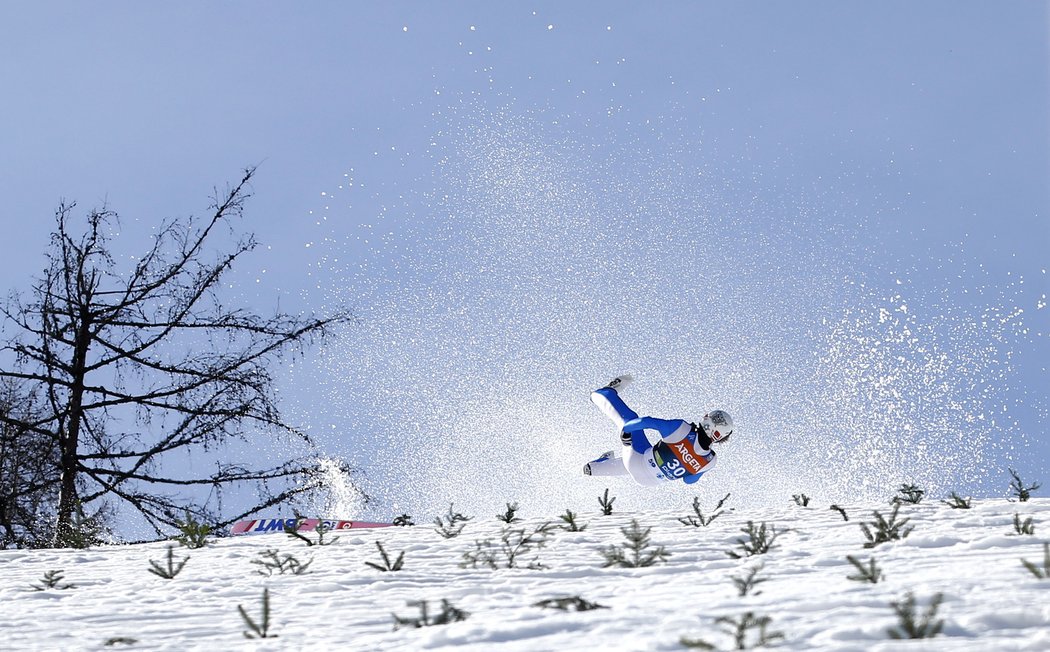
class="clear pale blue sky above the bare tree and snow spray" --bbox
[0,2,1050,516]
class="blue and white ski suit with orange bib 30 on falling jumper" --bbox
[590,387,715,486]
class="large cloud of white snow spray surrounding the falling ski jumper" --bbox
[296,96,1045,520]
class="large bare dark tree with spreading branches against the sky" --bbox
[0,168,359,545]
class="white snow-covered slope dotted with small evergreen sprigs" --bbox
[0,497,1050,651]
